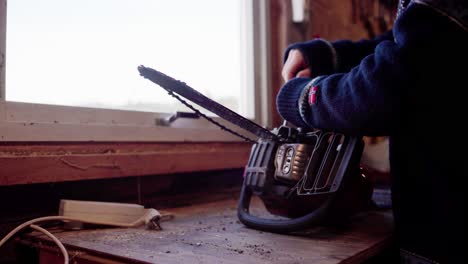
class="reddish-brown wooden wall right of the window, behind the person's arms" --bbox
[270,0,398,126]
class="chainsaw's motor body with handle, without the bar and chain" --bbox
[238,128,373,231]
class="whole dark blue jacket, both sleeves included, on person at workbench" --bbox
[277,1,468,263]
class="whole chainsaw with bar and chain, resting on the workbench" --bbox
[138,66,373,233]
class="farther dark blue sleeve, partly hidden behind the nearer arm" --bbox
[284,31,393,77]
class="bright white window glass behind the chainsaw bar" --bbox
[6,0,245,114]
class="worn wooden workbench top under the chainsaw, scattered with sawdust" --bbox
[19,199,393,264]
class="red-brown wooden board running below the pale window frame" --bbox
[0,143,251,186]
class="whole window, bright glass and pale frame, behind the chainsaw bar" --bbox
[0,0,270,141]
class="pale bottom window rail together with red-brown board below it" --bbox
[0,102,254,186]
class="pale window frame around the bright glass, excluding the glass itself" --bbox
[0,0,272,142]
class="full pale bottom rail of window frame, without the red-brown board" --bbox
[0,101,260,142]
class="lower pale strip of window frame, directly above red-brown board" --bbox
[0,121,250,143]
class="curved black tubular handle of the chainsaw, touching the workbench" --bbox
[237,185,334,233]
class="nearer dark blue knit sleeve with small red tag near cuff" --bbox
[277,38,407,136]
